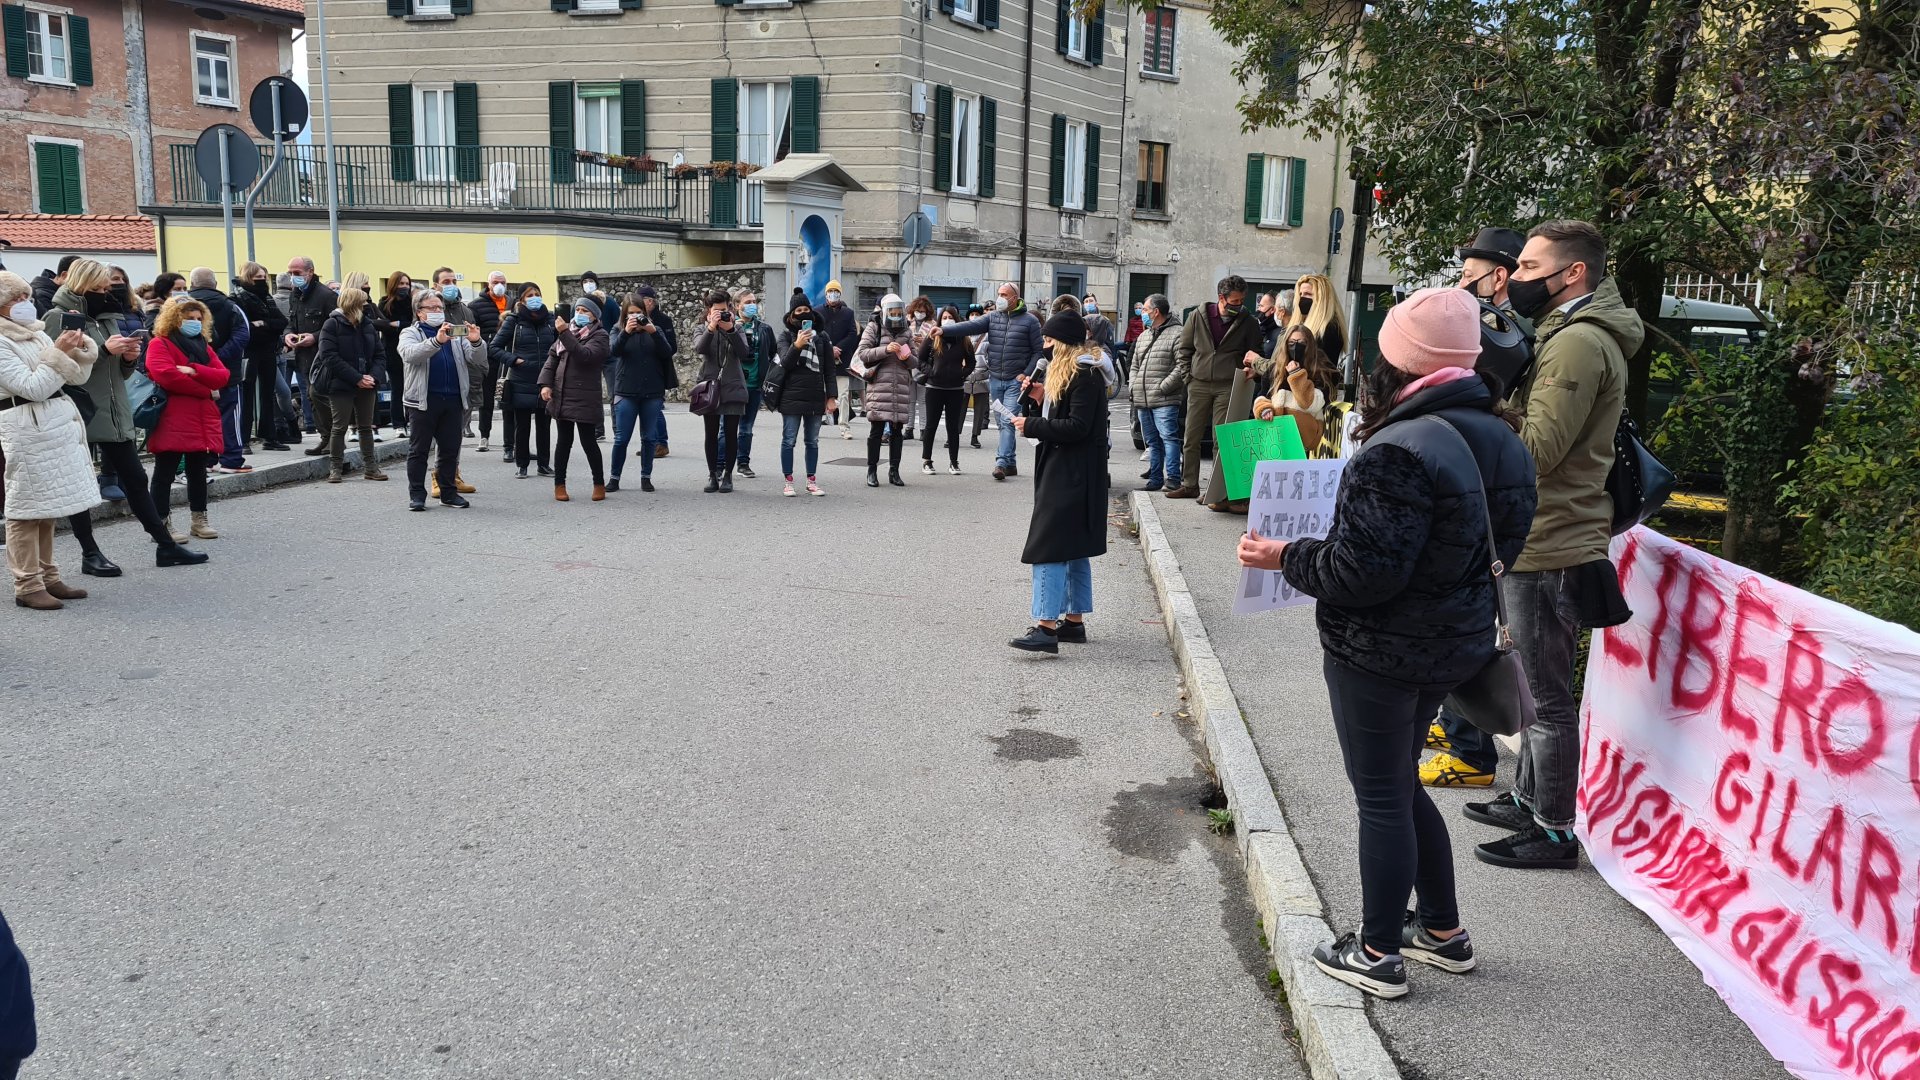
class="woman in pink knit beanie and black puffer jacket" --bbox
[1238,288,1534,997]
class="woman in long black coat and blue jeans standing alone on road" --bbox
[1008,311,1108,653]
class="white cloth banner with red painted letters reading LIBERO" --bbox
[1578,528,1920,1080]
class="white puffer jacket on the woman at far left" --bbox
[0,317,100,521]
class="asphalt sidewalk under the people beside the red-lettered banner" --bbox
[1128,494,1788,1080]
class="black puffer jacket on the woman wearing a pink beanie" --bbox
[1283,379,1534,690]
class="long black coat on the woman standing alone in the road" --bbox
[1020,365,1108,563]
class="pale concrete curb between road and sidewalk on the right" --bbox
[1133,492,1400,1080]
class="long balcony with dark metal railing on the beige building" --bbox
[167,142,758,229]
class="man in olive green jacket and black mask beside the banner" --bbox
[1467,221,1645,871]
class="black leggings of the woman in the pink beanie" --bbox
[1323,657,1459,953]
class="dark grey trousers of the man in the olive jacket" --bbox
[1501,571,1580,830]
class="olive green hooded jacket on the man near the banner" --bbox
[1513,277,1647,573]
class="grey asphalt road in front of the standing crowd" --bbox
[0,411,1302,1080]
